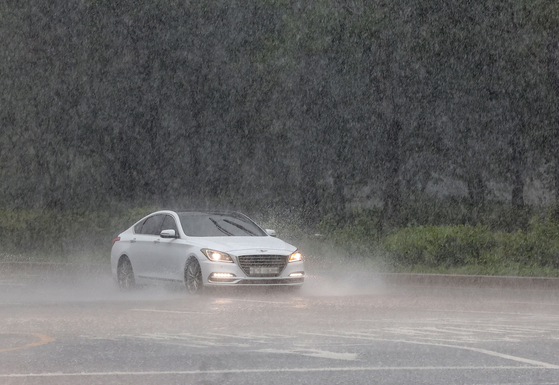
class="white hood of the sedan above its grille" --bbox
[190,237,297,255]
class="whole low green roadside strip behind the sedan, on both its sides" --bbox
[0,207,559,277]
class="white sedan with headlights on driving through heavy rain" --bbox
[111,211,305,293]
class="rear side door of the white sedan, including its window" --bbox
[132,214,165,279]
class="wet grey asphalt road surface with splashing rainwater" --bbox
[0,264,559,385]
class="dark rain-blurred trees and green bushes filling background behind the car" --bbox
[0,0,559,275]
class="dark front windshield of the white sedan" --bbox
[178,212,266,237]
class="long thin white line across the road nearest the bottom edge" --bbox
[0,366,556,378]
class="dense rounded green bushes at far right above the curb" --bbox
[381,218,559,275]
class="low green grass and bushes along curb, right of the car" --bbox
[312,208,559,277]
